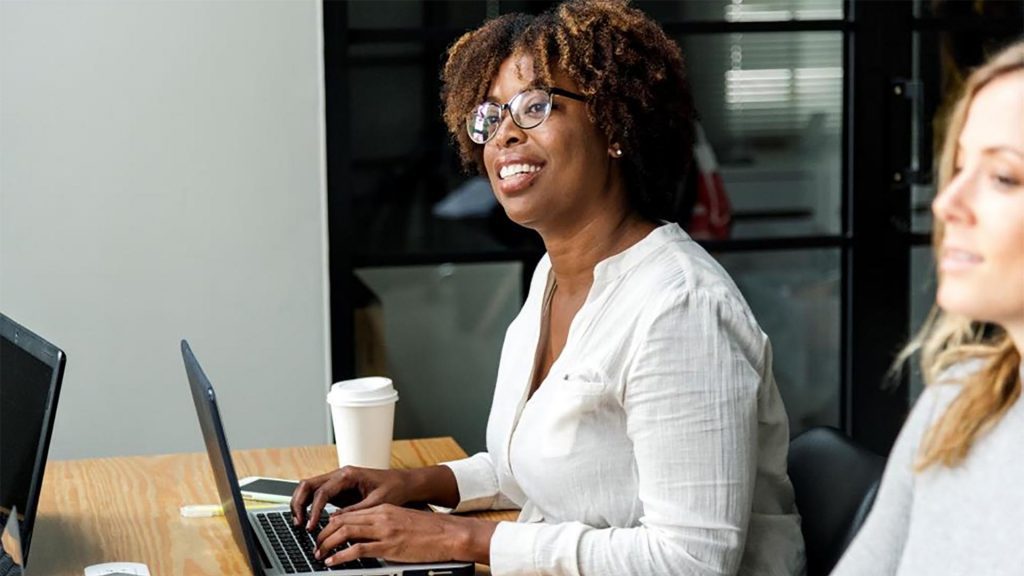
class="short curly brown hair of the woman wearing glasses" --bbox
[441,0,695,220]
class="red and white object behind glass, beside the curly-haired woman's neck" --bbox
[687,124,732,240]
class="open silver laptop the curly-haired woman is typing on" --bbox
[181,340,475,576]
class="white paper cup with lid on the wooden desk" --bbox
[327,376,398,469]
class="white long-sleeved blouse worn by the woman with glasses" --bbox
[446,224,804,576]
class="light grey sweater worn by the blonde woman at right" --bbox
[833,364,1024,576]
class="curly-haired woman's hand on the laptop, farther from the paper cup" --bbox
[316,504,498,566]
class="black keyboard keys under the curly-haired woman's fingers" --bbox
[256,511,381,574]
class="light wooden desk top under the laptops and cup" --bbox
[28,438,516,576]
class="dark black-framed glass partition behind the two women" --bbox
[325,0,1024,452]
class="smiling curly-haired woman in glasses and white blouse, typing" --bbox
[292,0,803,576]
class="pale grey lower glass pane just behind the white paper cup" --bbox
[356,262,523,453]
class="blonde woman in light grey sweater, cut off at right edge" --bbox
[834,42,1024,576]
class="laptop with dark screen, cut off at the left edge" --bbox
[0,314,66,566]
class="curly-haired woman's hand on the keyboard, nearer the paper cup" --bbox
[291,466,415,530]
